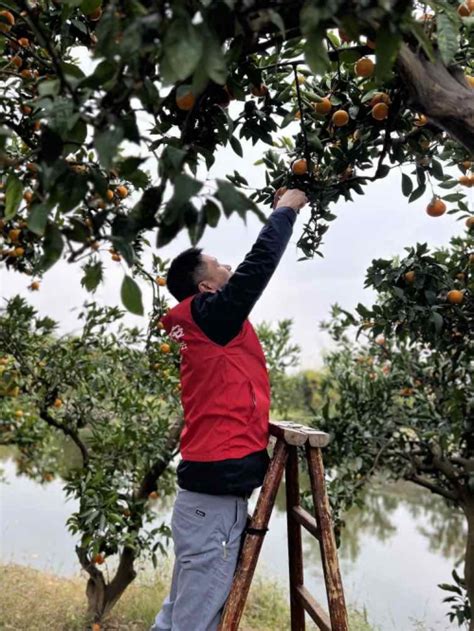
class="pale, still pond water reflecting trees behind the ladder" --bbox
[0,456,465,631]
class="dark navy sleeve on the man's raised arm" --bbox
[191,207,296,344]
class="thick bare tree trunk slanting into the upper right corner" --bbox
[398,44,474,153]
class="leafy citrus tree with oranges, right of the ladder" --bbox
[306,237,474,628]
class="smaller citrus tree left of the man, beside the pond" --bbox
[0,256,182,623]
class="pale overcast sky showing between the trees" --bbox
[0,49,466,368]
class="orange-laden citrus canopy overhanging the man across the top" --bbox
[0,0,474,313]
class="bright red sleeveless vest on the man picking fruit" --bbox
[162,296,270,462]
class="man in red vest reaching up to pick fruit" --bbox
[150,189,307,631]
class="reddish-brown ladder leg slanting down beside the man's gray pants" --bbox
[219,440,288,631]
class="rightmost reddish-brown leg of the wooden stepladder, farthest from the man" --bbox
[306,443,349,631]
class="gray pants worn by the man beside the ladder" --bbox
[150,487,248,631]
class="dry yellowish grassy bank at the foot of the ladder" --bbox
[0,564,374,631]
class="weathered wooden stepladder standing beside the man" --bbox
[219,421,349,631]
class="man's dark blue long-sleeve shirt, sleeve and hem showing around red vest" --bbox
[177,207,296,495]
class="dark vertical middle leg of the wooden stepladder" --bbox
[285,446,305,631]
